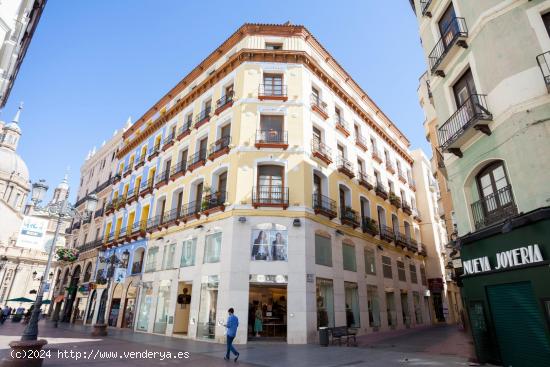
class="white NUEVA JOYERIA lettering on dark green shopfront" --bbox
[462,244,544,275]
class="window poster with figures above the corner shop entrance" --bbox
[251,229,288,261]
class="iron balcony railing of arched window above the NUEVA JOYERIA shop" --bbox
[471,185,518,230]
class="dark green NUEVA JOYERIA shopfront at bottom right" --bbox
[461,208,550,367]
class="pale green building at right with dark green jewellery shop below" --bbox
[411,0,550,366]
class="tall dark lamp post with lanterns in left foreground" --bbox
[6,180,98,366]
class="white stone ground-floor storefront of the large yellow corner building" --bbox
[125,217,433,344]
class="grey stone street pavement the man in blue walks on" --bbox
[0,321,478,367]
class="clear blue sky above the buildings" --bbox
[0,0,429,200]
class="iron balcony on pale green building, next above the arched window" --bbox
[437,94,493,157]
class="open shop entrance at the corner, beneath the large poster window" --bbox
[248,283,287,341]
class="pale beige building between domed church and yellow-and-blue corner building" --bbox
[52,125,124,324]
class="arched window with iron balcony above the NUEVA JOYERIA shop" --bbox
[472,161,517,229]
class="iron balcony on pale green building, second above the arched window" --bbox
[428,18,468,77]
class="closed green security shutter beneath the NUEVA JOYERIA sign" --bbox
[487,282,550,367]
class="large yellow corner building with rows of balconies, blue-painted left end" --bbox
[89,24,440,343]
